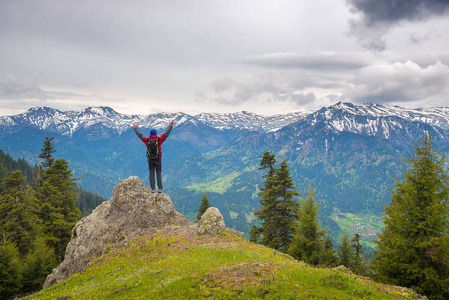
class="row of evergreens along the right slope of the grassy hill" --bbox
[250,128,449,299]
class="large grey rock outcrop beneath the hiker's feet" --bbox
[44,177,243,288]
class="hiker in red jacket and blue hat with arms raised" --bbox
[133,120,174,193]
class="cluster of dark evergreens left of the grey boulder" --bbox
[0,137,104,299]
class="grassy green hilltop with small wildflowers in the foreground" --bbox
[24,235,417,299]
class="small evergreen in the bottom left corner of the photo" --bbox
[0,241,22,299]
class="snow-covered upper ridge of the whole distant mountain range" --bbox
[0,102,449,139]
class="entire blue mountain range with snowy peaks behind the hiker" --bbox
[0,102,449,243]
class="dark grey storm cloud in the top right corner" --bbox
[346,0,449,51]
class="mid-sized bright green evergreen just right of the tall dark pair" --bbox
[289,186,326,265]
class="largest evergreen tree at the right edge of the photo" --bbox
[373,128,449,299]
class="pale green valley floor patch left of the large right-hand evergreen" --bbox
[331,210,385,249]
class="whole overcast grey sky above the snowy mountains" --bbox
[0,0,449,115]
